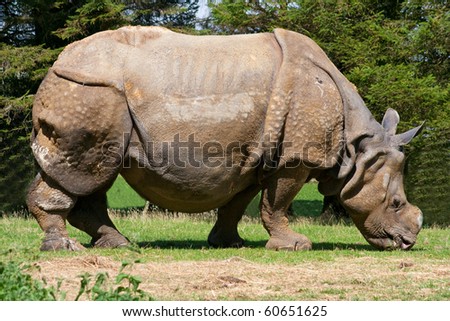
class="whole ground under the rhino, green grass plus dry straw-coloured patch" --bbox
[0,212,450,300]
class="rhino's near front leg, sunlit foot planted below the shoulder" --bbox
[260,167,312,251]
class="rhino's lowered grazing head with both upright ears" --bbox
[339,109,423,250]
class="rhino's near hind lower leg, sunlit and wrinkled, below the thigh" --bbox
[27,174,84,251]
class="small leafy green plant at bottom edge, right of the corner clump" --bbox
[75,262,152,301]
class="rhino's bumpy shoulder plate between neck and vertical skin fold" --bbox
[264,29,344,168]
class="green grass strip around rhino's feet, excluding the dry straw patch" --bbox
[0,212,450,264]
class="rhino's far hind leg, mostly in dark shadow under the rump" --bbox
[67,191,129,248]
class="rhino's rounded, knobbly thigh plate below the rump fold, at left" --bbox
[31,71,132,196]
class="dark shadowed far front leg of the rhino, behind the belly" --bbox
[208,186,261,248]
